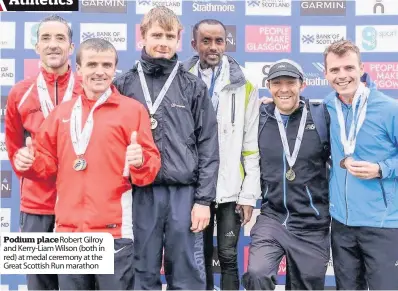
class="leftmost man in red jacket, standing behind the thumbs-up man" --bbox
[5,16,81,290]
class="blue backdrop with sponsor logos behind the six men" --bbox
[0,0,398,290]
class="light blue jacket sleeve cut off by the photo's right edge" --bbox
[378,104,398,179]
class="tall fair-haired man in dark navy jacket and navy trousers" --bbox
[115,7,219,290]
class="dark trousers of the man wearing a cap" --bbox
[242,215,330,290]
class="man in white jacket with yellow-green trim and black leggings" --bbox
[184,19,261,290]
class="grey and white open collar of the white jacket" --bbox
[183,55,246,90]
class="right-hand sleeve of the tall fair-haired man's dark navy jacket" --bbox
[192,79,220,205]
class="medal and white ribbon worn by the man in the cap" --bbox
[275,100,308,181]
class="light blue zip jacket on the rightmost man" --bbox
[324,75,398,228]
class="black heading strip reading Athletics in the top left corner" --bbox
[0,0,79,11]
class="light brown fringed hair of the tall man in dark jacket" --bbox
[140,6,183,38]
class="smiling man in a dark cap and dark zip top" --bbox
[242,60,330,290]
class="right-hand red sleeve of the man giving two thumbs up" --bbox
[130,104,161,187]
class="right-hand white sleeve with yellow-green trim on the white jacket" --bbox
[237,81,261,207]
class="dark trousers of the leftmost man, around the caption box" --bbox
[19,211,59,290]
